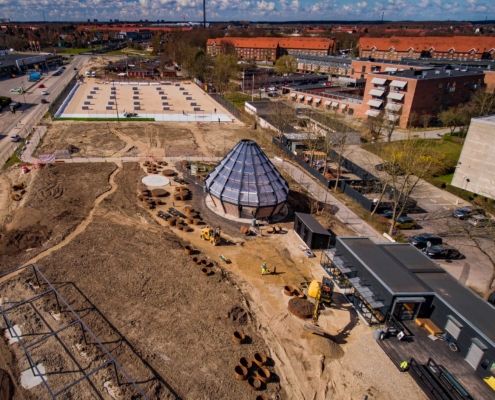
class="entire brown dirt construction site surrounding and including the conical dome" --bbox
[0,77,425,400]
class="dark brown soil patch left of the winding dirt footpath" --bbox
[0,163,116,271]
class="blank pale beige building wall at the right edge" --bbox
[452,115,495,199]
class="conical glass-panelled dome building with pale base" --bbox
[205,139,289,218]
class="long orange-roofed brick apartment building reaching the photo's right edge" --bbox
[359,36,495,61]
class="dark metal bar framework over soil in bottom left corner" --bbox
[0,265,180,399]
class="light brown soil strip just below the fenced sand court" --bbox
[35,121,257,157]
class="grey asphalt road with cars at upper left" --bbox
[0,56,90,164]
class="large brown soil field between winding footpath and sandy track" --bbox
[7,164,280,400]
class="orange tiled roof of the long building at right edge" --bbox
[359,36,495,53]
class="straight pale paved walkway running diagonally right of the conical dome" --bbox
[272,157,386,242]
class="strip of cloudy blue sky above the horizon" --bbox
[0,0,495,21]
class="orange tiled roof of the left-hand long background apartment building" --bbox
[206,36,333,50]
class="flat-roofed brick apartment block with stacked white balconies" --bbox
[360,68,484,128]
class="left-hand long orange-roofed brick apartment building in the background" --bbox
[206,36,335,62]
